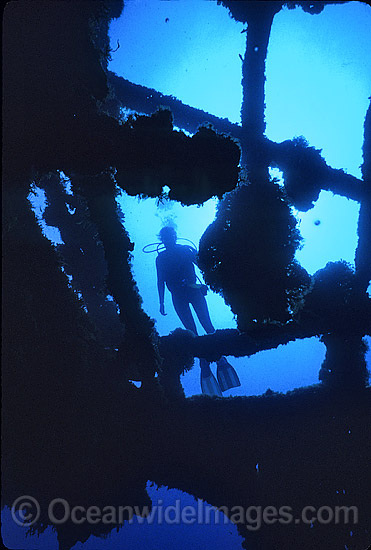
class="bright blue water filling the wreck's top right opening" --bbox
[265,2,371,177]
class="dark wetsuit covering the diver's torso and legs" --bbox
[156,244,215,334]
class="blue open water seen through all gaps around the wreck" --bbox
[2,0,371,550]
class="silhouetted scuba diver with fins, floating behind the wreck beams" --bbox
[156,226,241,397]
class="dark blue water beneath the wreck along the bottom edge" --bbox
[2,482,247,550]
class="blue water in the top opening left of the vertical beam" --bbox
[109,0,246,122]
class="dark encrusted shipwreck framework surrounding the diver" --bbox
[3,0,371,550]
